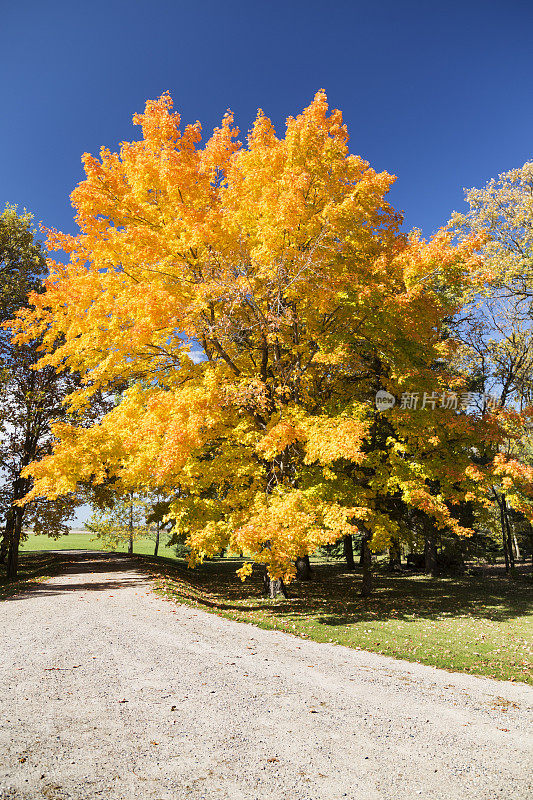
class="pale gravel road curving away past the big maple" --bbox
[0,553,533,800]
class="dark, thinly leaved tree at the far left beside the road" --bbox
[0,206,84,578]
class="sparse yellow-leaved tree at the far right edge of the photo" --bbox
[451,162,533,569]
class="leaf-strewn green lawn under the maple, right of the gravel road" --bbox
[137,557,533,683]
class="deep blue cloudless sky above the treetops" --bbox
[0,0,533,524]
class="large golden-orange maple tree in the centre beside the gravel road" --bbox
[11,92,520,593]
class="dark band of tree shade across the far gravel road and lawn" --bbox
[4,550,533,628]
